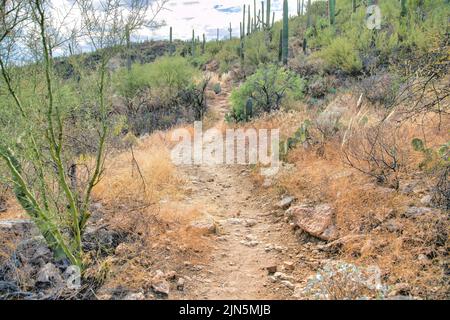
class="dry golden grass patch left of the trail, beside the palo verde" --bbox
[90,128,213,292]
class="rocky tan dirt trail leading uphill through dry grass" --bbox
[172,81,306,299]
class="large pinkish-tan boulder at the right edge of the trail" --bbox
[287,204,338,241]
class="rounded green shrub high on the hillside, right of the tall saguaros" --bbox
[319,37,362,75]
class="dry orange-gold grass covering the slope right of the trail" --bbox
[251,98,450,299]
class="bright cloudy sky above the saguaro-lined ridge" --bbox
[51,0,306,41]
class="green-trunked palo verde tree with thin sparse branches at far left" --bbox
[0,0,167,268]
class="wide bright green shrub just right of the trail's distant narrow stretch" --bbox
[230,65,304,121]
